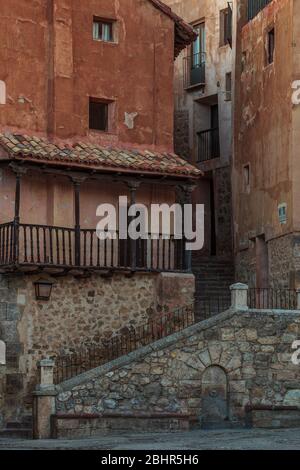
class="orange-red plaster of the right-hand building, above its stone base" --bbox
[233,0,293,248]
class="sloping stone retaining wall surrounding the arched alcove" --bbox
[56,311,300,425]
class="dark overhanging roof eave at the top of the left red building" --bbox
[149,0,197,58]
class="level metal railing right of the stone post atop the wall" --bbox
[248,288,298,310]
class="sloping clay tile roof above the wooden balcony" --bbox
[0,133,202,182]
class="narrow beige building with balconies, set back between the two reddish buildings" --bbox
[167,0,235,302]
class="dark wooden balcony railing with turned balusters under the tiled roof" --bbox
[0,222,188,271]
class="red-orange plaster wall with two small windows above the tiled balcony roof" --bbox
[0,0,174,150]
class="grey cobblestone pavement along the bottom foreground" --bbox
[0,429,300,450]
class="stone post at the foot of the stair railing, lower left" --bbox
[33,359,57,439]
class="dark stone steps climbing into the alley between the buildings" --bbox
[193,257,235,319]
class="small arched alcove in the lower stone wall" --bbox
[201,366,229,428]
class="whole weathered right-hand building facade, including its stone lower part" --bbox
[232,0,300,288]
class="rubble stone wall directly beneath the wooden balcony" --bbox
[0,274,195,426]
